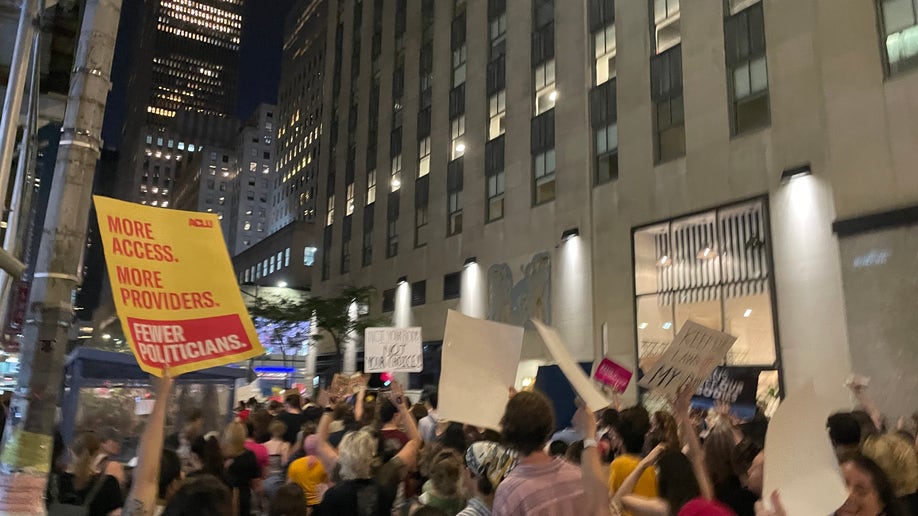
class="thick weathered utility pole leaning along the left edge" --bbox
[0,0,121,514]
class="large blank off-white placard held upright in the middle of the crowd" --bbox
[438,310,523,430]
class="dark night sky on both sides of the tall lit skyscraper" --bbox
[102,0,295,148]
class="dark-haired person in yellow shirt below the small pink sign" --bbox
[609,405,657,512]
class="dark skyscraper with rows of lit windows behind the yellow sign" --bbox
[119,0,243,207]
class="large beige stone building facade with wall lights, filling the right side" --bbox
[314,0,918,415]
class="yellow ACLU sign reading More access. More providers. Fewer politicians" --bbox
[93,196,264,376]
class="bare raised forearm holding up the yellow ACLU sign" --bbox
[122,370,173,516]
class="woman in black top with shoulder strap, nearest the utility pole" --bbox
[49,432,124,516]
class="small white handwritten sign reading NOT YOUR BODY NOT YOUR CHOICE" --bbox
[363,328,424,373]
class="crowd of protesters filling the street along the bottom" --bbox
[41,368,918,516]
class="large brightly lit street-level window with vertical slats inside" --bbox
[633,201,776,367]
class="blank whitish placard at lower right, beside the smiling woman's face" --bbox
[763,382,848,514]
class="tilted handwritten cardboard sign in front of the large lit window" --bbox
[638,321,736,398]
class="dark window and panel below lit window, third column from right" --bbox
[650,45,685,163]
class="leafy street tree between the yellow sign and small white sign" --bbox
[249,286,385,370]
